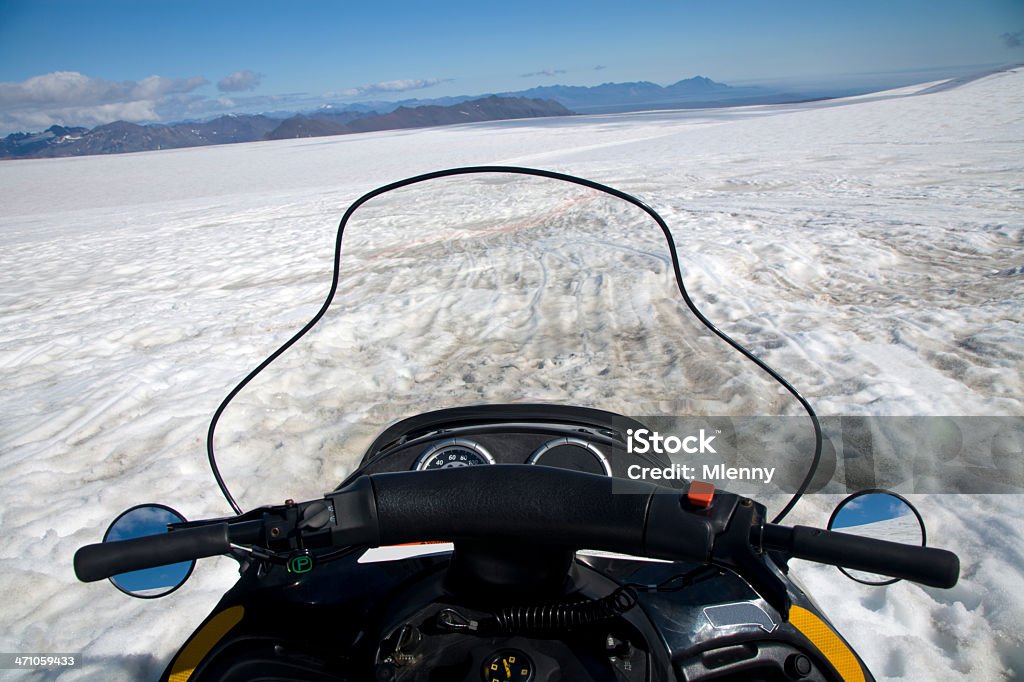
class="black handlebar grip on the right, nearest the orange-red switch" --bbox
[762,524,959,588]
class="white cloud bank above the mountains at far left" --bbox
[0,71,209,130]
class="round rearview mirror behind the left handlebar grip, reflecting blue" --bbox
[103,505,196,599]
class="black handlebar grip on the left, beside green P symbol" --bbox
[75,523,230,583]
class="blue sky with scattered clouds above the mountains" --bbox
[0,0,1024,132]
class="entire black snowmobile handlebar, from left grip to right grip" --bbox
[75,465,959,602]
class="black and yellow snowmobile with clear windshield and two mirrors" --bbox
[75,167,959,682]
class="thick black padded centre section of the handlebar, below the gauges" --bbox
[328,464,720,561]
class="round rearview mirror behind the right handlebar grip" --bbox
[828,489,927,585]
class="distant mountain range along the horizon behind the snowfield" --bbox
[0,76,801,159]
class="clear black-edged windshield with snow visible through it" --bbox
[215,173,807,509]
